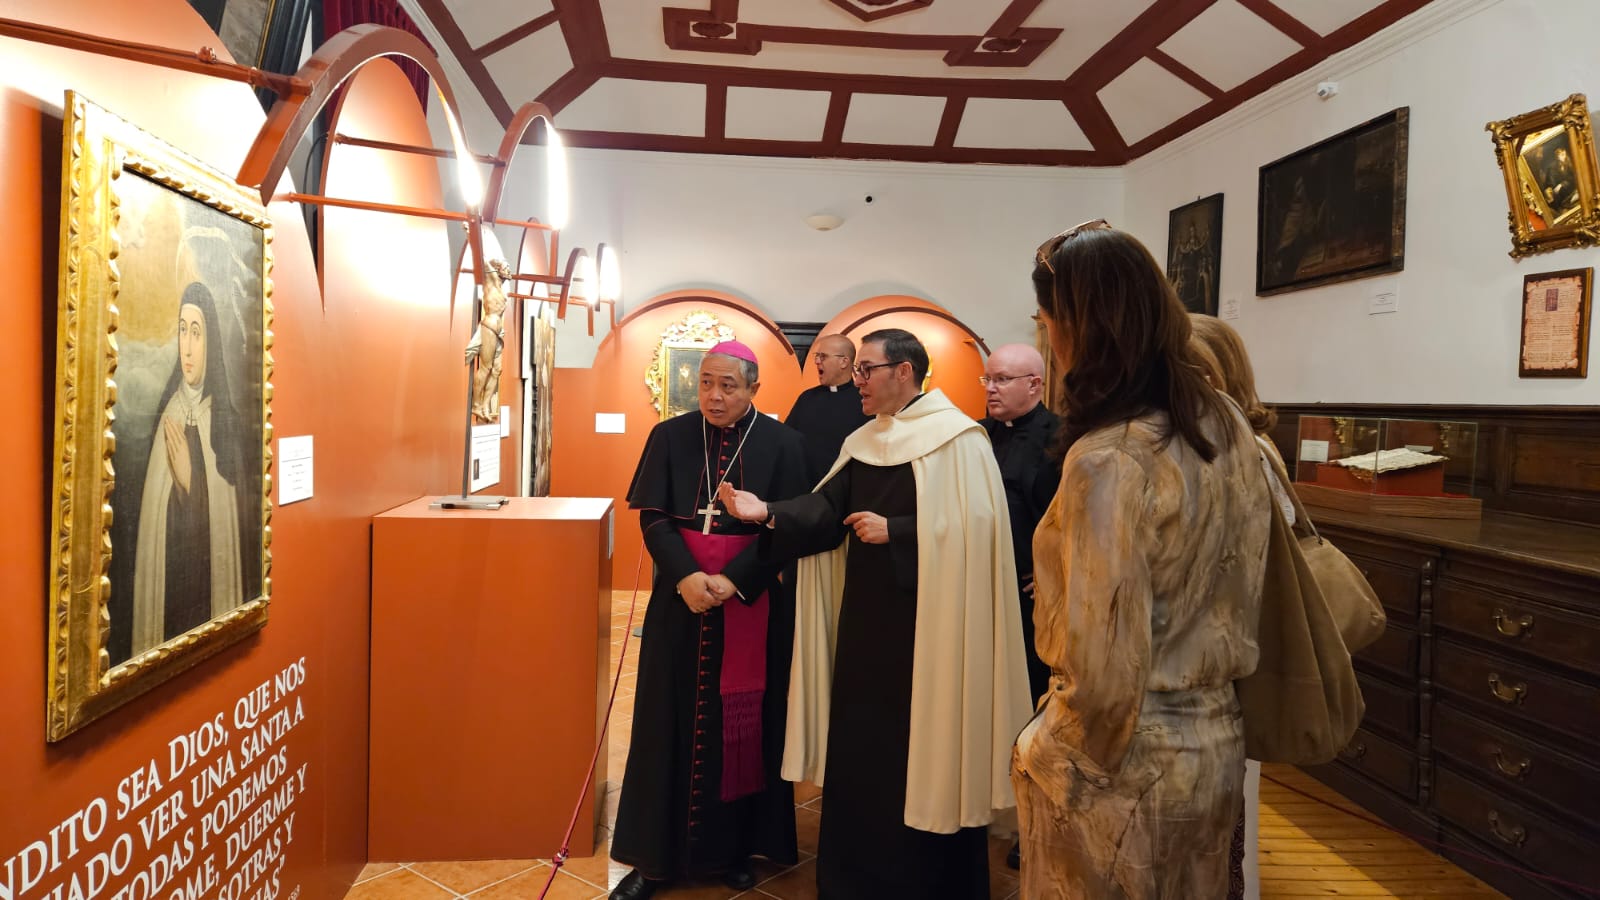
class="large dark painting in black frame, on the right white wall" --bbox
[1256,107,1411,296]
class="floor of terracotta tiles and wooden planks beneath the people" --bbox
[346,591,1499,900]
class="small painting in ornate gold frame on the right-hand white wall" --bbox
[1485,94,1600,258]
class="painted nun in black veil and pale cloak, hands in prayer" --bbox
[133,282,243,655]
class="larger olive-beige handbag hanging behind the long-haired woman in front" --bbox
[1234,453,1381,765]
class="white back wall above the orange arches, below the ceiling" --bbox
[492,151,1123,365]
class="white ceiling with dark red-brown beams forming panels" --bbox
[416,0,1429,165]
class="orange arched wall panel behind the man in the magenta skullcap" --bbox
[550,290,816,582]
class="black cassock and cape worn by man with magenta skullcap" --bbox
[611,407,810,879]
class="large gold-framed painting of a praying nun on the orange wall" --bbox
[46,91,272,740]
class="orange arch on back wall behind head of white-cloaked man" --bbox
[822,295,986,420]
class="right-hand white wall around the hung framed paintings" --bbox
[1126,0,1600,404]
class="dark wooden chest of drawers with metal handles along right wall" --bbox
[1309,509,1600,900]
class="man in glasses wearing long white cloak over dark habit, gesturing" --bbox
[722,328,1030,900]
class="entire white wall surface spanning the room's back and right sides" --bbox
[425,0,1600,404]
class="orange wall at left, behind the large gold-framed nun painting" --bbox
[0,7,480,900]
